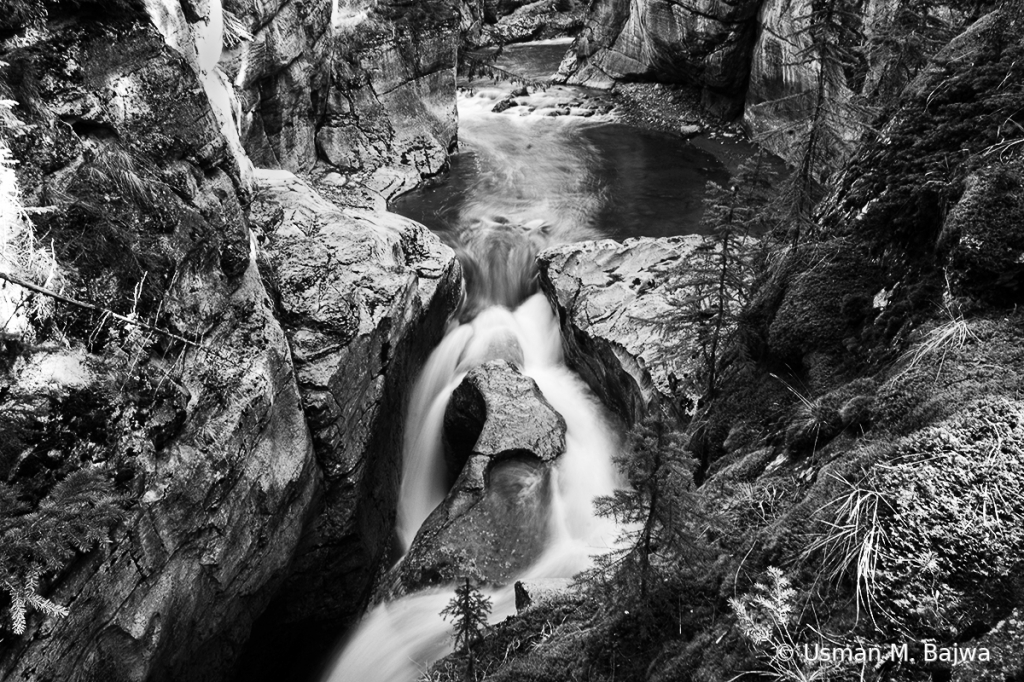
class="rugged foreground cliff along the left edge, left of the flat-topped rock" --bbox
[0,16,318,682]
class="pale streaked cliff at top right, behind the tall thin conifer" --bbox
[743,0,992,167]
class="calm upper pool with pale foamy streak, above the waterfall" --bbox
[391,41,750,242]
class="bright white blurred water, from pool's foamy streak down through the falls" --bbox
[327,49,622,682]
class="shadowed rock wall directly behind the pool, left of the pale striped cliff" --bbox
[564,0,761,117]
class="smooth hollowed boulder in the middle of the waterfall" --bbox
[383,360,565,595]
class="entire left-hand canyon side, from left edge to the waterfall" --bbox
[0,1,461,680]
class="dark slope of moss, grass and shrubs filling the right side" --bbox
[434,3,1024,682]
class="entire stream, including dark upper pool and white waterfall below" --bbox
[323,41,741,682]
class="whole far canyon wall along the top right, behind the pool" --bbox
[560,0,991,159]
